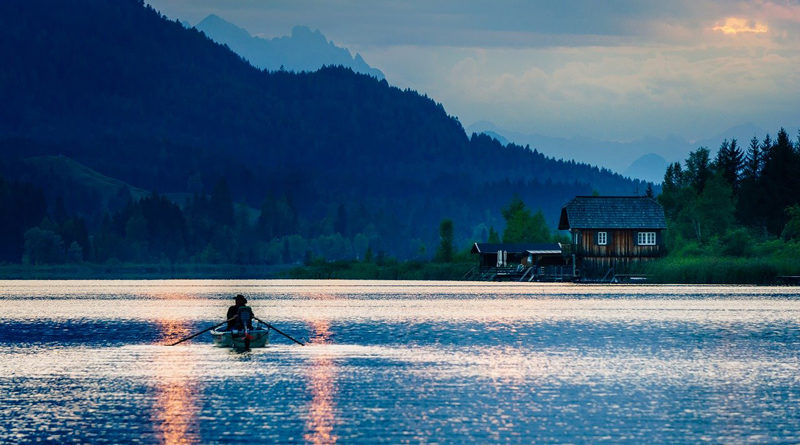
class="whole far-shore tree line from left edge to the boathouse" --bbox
[6,166,559,265]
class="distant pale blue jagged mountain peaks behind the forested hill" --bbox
[194,14,384,80]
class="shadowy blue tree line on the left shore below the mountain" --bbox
[8,178,382,265]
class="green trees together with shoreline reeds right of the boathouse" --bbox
[650,128,800,283]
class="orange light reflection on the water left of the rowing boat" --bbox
[152,314,200,445]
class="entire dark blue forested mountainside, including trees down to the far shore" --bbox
[0,0,647,264]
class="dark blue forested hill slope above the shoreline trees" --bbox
[0,0,645,256]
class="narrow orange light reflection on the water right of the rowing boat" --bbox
[303,297,337,444]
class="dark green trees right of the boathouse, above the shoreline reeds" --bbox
[658,128,800,256]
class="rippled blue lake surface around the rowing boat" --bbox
[0,280,800,444]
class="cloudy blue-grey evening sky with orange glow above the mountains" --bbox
[149,0,800,141]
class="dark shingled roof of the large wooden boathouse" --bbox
[558,196,667,230]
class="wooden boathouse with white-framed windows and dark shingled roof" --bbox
[558,196,667,279]
